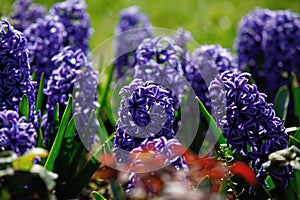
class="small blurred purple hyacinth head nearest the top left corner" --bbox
[10,0,46,32]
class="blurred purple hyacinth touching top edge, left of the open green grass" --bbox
[49,0,92,54]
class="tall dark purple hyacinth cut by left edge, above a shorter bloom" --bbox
[0,21,35,119]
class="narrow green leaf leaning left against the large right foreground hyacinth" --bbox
[196,97,226,144]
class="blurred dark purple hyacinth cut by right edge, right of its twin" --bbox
[262,10,300,99]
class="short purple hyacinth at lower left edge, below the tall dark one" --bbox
[0,110,37,155]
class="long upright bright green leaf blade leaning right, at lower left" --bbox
[45,97,72,171]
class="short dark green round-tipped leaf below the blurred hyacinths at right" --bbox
[274,85,290,120]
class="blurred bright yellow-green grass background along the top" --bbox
[0,0,300,50]
